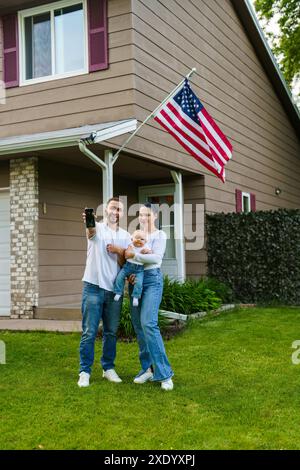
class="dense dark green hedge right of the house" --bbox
[206,209,300,304]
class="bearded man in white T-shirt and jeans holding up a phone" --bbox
[78,197,131,387]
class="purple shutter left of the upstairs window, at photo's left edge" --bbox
[2,13,19,88]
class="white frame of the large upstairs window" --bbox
[18,0,89,86]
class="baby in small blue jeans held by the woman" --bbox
[114,230,151,307]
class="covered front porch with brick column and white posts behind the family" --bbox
[0,122,206,320]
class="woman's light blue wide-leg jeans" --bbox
[129,268,174,381]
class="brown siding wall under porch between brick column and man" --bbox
[39,156,137,307]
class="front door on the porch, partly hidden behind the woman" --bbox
[139,184,179,279]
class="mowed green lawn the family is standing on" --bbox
[0,308,300,450]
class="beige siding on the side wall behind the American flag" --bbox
[106,0,300,212]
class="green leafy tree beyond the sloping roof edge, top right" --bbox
[254,0,300,86]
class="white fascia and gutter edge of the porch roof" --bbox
[0,119,137,156]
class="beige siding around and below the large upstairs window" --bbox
[0,0,134,138]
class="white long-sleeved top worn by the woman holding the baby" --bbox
[133,230,167,270]
